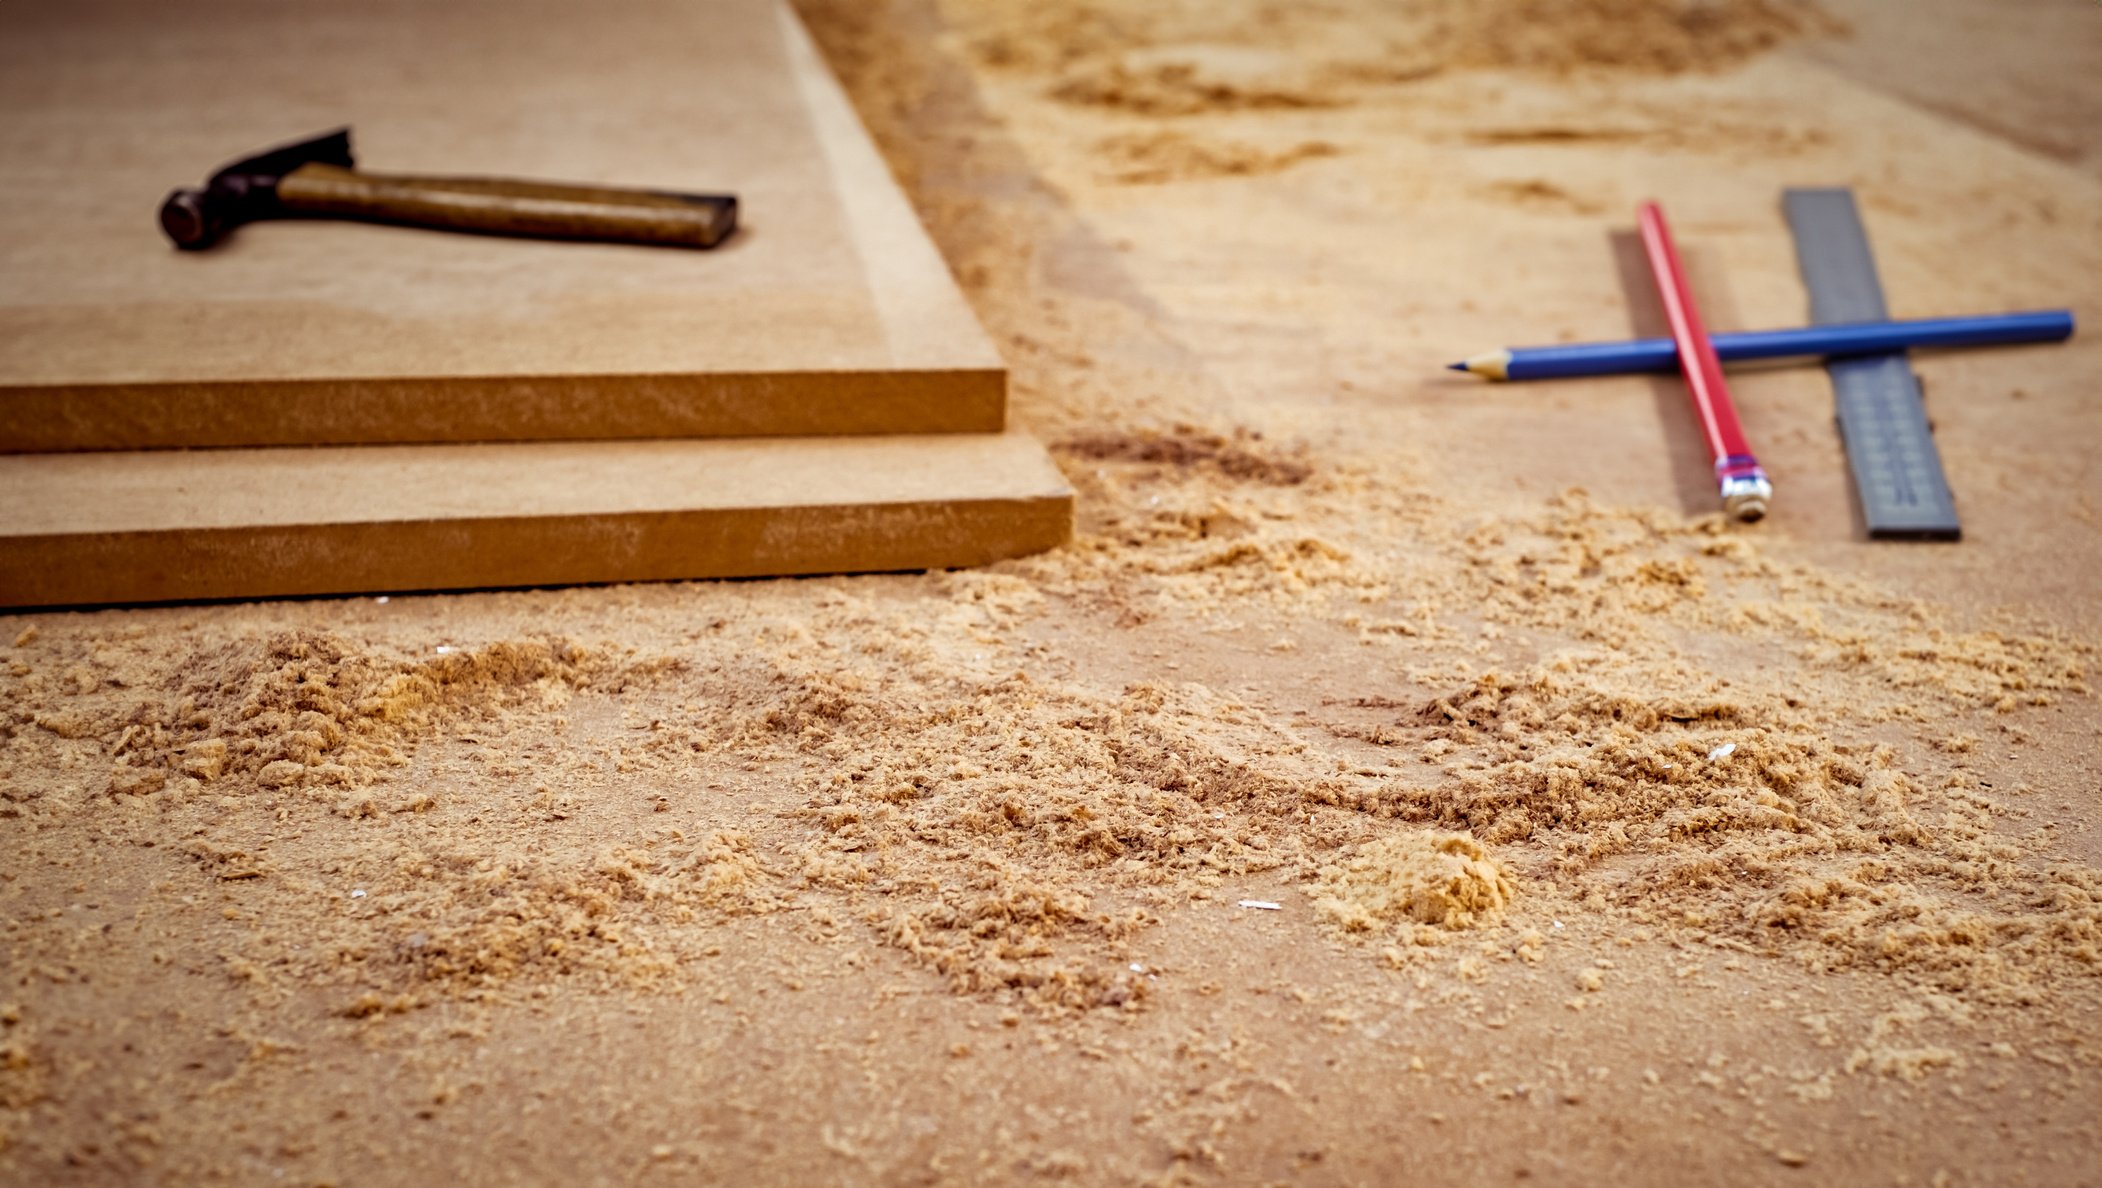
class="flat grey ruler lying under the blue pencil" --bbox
[1780,189,1963,540]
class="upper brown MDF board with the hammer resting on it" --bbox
[0,0,1005,450]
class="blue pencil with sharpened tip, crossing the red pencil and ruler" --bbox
[1452,309,2073,381]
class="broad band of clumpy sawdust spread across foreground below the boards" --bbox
[24,468,2102,1009]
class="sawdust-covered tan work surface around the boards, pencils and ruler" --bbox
[0,0,2102,1186]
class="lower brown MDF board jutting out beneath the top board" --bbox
[0,433,1072,608]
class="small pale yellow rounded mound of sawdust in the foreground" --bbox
[1314,833,1516,934]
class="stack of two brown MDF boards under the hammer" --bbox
[0,0,1072,606]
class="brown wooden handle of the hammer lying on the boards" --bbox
[277,164,738,248]
